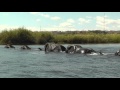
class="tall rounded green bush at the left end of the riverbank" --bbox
[0,28,34,44]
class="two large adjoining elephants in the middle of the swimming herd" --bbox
[45,43,103,55]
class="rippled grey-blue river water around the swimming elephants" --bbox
[0,44,120,78]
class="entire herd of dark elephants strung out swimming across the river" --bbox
[5,43,120,56]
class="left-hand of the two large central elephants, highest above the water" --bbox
[44,43,66,52]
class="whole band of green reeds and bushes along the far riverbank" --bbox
[0,27,120,44]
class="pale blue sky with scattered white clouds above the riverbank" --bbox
[0,12,120,32]
